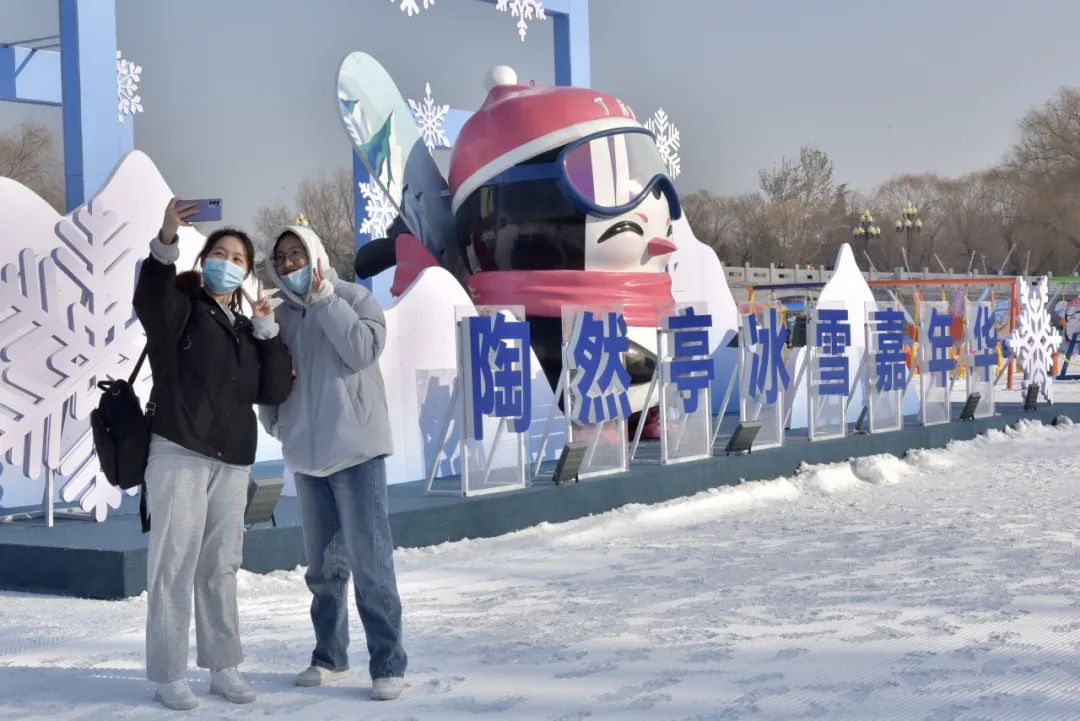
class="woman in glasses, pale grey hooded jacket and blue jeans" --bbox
[259,226,406,700]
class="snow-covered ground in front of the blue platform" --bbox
[0,418,1080,721]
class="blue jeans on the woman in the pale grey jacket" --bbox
[296,458,407,679]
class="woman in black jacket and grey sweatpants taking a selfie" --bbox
[134,199,293,709]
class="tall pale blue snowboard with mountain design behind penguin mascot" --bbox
[338,53,463,280]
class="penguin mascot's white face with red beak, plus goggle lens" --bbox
[567,129,675,273]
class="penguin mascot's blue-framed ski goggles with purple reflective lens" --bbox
[489,127,683,220]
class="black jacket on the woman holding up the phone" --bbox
[134,256,293,465]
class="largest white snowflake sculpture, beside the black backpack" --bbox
[0,202,149,520]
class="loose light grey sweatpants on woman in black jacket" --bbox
[146,436,248,683]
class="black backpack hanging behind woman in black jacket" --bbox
[90,349,152,533]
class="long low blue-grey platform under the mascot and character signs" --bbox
[0,404,1080,599]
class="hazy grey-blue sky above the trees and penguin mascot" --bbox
[0,0,1080,226]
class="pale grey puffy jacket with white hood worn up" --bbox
[259,226,392,477]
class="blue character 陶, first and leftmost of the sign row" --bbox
[465,313,532,440]
